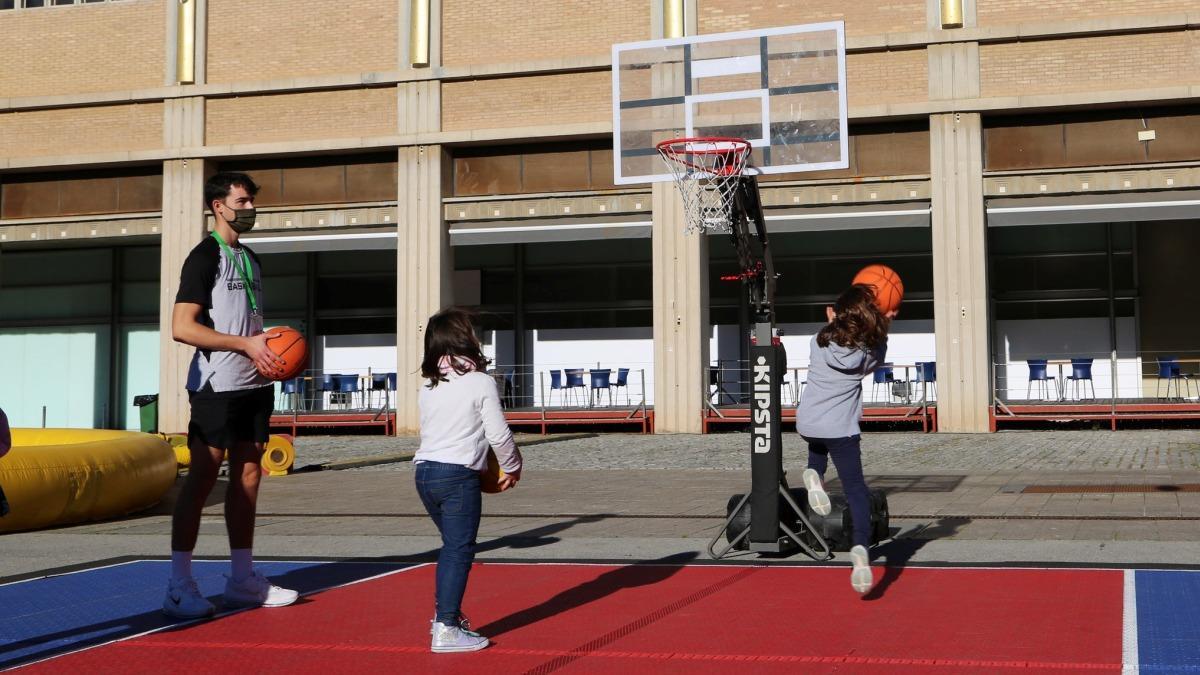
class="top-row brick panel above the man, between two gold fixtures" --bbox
[208,0,400,82]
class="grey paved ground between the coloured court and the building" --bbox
[0,431,1200,577]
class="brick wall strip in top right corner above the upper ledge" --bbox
[976,0,1196,25]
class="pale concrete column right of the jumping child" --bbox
[929,113,991,431]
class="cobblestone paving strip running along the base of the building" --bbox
[296,430,1200,473]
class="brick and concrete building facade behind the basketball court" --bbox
[0,0,1200,432]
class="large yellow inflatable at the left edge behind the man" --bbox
[0,429,175,532]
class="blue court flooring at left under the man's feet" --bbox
[0,561,409,669]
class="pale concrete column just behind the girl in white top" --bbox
[396,145,454,432]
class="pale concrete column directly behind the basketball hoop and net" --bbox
[650,183,709,434]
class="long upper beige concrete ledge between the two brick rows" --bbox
[0,11,1200,112]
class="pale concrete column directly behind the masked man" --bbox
[158,160,206,432]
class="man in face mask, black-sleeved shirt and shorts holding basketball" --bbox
[162,173,298,619]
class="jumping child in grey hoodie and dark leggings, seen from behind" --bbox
[796,285,895,593]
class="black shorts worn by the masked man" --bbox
[187,384,275,450]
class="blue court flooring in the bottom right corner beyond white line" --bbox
[1135,571,1200,673]
